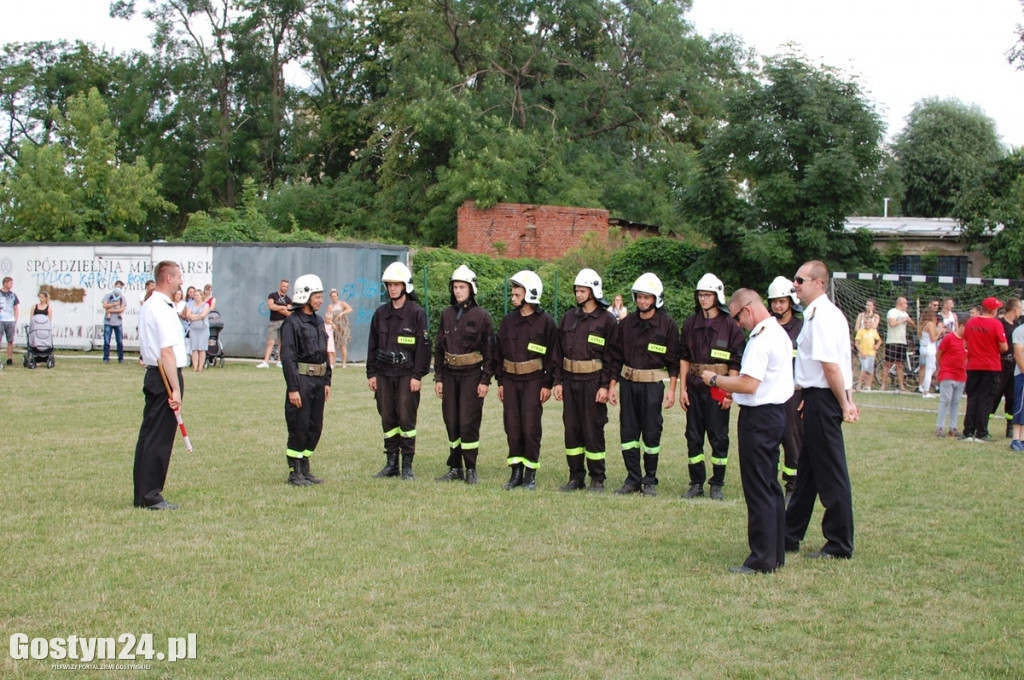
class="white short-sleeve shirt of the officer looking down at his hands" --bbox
[732,316,793,407]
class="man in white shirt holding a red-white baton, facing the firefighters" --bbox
[133,260,186,510]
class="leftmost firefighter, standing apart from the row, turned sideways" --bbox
[281,273,332,486]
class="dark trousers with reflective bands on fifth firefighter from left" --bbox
[562,373,608,481]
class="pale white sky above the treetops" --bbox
[0,0,1024,146]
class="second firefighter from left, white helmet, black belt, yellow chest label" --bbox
[367,262,430,480]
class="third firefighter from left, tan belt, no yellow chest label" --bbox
[434,264,495,484]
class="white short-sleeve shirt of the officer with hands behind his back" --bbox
[794,295,853,389]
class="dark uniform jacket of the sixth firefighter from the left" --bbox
[611,309,679,381]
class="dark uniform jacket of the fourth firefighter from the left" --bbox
[492,307,558,388]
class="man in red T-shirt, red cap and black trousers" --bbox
[961,297,1009,442]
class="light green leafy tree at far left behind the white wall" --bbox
[0,88,172,242]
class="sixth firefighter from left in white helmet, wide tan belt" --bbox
[608,272,679,496]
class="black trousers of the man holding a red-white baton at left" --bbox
[132,368,185,508]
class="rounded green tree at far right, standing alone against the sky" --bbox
[894,97,1004,217]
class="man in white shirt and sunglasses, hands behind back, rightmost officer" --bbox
[785,260,856,559]
